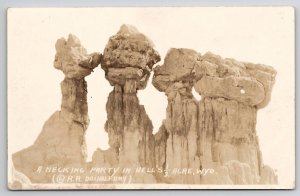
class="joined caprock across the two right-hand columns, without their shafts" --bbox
[153,48,276,108]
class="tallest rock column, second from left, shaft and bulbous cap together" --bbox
[93,25,160,183]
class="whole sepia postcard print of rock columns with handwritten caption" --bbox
[7,6,295,190]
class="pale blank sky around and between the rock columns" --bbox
[8,7,295,185]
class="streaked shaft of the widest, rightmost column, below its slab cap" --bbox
[198,98,262,184]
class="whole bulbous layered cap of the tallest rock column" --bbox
[101,25,160,89]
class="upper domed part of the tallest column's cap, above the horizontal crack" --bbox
[101,25,160,71]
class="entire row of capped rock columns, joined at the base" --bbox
[12,25,277,186]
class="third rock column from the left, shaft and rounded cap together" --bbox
[152,48,200,184]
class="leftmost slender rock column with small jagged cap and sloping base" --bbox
[12,34,101,183]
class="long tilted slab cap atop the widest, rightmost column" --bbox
[194,52,276,108]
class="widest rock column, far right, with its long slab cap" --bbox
[194,53,277,184]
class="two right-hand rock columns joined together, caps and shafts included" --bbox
[152,49,277,184]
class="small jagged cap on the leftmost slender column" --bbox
[54,34,101,79]
